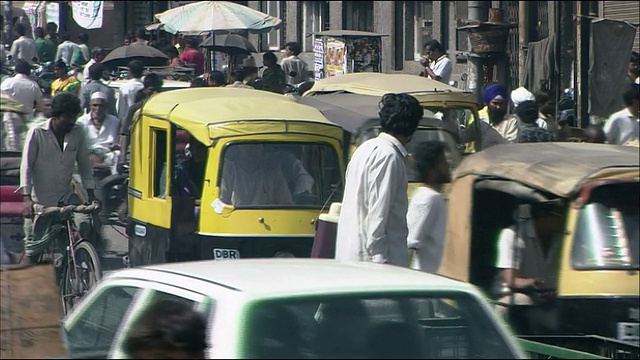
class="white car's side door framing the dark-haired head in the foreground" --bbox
[109,282,214,359]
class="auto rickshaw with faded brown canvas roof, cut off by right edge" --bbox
[438,143,640,344]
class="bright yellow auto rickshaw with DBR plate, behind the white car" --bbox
[128,88,344,266]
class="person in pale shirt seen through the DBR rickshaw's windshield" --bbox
[220,144,293,206]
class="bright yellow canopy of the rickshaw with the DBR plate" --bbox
[141,88,343,145]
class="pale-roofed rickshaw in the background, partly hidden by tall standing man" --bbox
[299,73,482,192]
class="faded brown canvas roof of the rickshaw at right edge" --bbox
[453,142,640,197]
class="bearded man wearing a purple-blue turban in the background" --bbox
[479,83,520,143]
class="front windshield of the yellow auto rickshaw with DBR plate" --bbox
[219,141,342,208]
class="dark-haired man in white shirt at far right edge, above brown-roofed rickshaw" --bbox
[604,84,640,145]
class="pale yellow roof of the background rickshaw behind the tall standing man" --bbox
[303,73,477,105]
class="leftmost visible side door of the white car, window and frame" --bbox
[63,281,145,359]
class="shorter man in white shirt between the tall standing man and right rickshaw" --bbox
[407,141,451,273]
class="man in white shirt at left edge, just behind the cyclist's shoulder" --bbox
[0,59,42,151]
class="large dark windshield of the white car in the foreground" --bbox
[244,293,515,359]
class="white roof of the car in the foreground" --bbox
[112,258,474,296]
